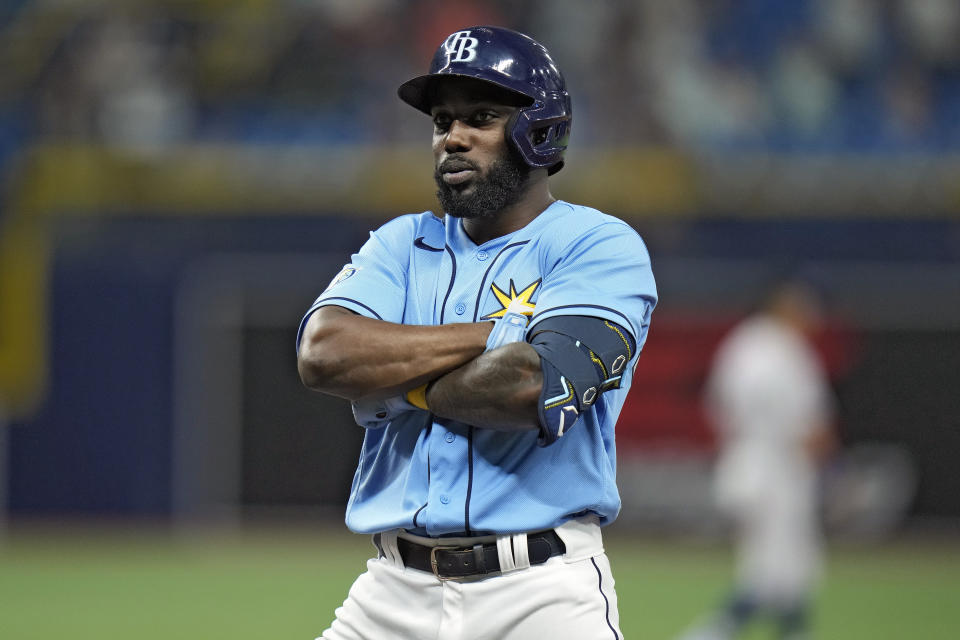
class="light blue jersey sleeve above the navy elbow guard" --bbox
[530,222,657,352]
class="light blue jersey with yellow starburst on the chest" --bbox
[297,201,657,536]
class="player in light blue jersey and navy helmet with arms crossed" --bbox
[297,27,657,640]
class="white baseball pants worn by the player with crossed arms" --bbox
[317,520,623,640]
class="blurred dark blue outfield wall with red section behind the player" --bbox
[8,212,960,523]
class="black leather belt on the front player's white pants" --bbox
[375,529,566,580]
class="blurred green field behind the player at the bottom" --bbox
[0,526,960,640]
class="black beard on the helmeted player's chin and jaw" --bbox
[433,149,530,218]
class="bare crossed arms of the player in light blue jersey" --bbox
[297,305,543,431]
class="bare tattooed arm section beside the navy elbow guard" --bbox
[427,342,543,431]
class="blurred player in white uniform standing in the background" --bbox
[684,281,835,640]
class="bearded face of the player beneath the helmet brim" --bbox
[431,78,530,218]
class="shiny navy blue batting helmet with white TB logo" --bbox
[397,27,573,175]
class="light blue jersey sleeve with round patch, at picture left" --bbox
[296,216,416,350]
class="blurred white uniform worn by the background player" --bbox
[707,315,832,606]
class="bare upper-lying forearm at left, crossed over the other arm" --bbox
[297,306,493,399]
